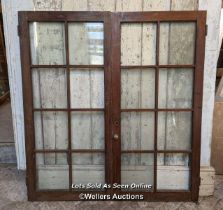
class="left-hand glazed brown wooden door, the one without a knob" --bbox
[19,12,111,200]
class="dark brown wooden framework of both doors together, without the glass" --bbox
[19,11,206,201]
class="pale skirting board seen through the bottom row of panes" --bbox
[39,165,189,190]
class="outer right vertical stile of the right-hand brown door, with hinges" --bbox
[190,12,206,201]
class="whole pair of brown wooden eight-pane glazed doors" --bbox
[19,11,206,201]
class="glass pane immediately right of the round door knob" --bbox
[121,112,154,150]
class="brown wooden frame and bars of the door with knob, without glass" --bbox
[112,11,206,201]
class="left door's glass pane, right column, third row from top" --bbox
[71,112,105,149]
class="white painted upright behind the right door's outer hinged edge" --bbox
[199,0,221,166]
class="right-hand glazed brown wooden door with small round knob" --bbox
[112,12,205,200]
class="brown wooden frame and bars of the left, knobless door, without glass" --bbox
[19,11,112,201]
